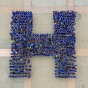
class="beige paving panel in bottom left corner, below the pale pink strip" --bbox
[0,57,24,88]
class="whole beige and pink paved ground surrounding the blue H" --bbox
[0,0,88,88]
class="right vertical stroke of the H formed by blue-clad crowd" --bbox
[53,11,76,78]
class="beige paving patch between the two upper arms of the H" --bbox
[33,12,54,34]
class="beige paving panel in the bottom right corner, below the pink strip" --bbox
[76,57,88,88]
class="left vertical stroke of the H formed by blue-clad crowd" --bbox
[9,11,33,78]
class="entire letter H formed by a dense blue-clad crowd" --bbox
[10,11,76,78]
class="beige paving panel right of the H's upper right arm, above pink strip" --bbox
[75,15,88,49]
